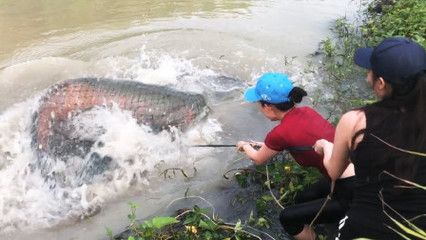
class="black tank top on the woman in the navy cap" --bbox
[351,106,426,219]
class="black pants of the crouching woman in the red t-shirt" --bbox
[280,177,355,236]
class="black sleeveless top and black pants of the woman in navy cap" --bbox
[339,107,426,239]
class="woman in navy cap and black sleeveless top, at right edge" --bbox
[315,37,426,239]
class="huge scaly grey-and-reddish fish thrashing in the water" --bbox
[33,78,208,185]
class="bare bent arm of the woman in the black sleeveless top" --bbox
[314,111,361,180]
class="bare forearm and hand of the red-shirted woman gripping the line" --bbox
[237,141,278,165]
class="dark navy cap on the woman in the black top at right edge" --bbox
[354,37,426,84]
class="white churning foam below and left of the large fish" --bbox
[0,101,221,232]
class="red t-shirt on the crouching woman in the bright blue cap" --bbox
[265,107,334,176]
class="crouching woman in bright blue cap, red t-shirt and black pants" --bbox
[237,73,353,239]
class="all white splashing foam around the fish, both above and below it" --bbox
[0,49,236,234]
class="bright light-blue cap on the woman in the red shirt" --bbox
[244,73,293,104]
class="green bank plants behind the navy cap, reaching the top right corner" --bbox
[313,0,426,122]
